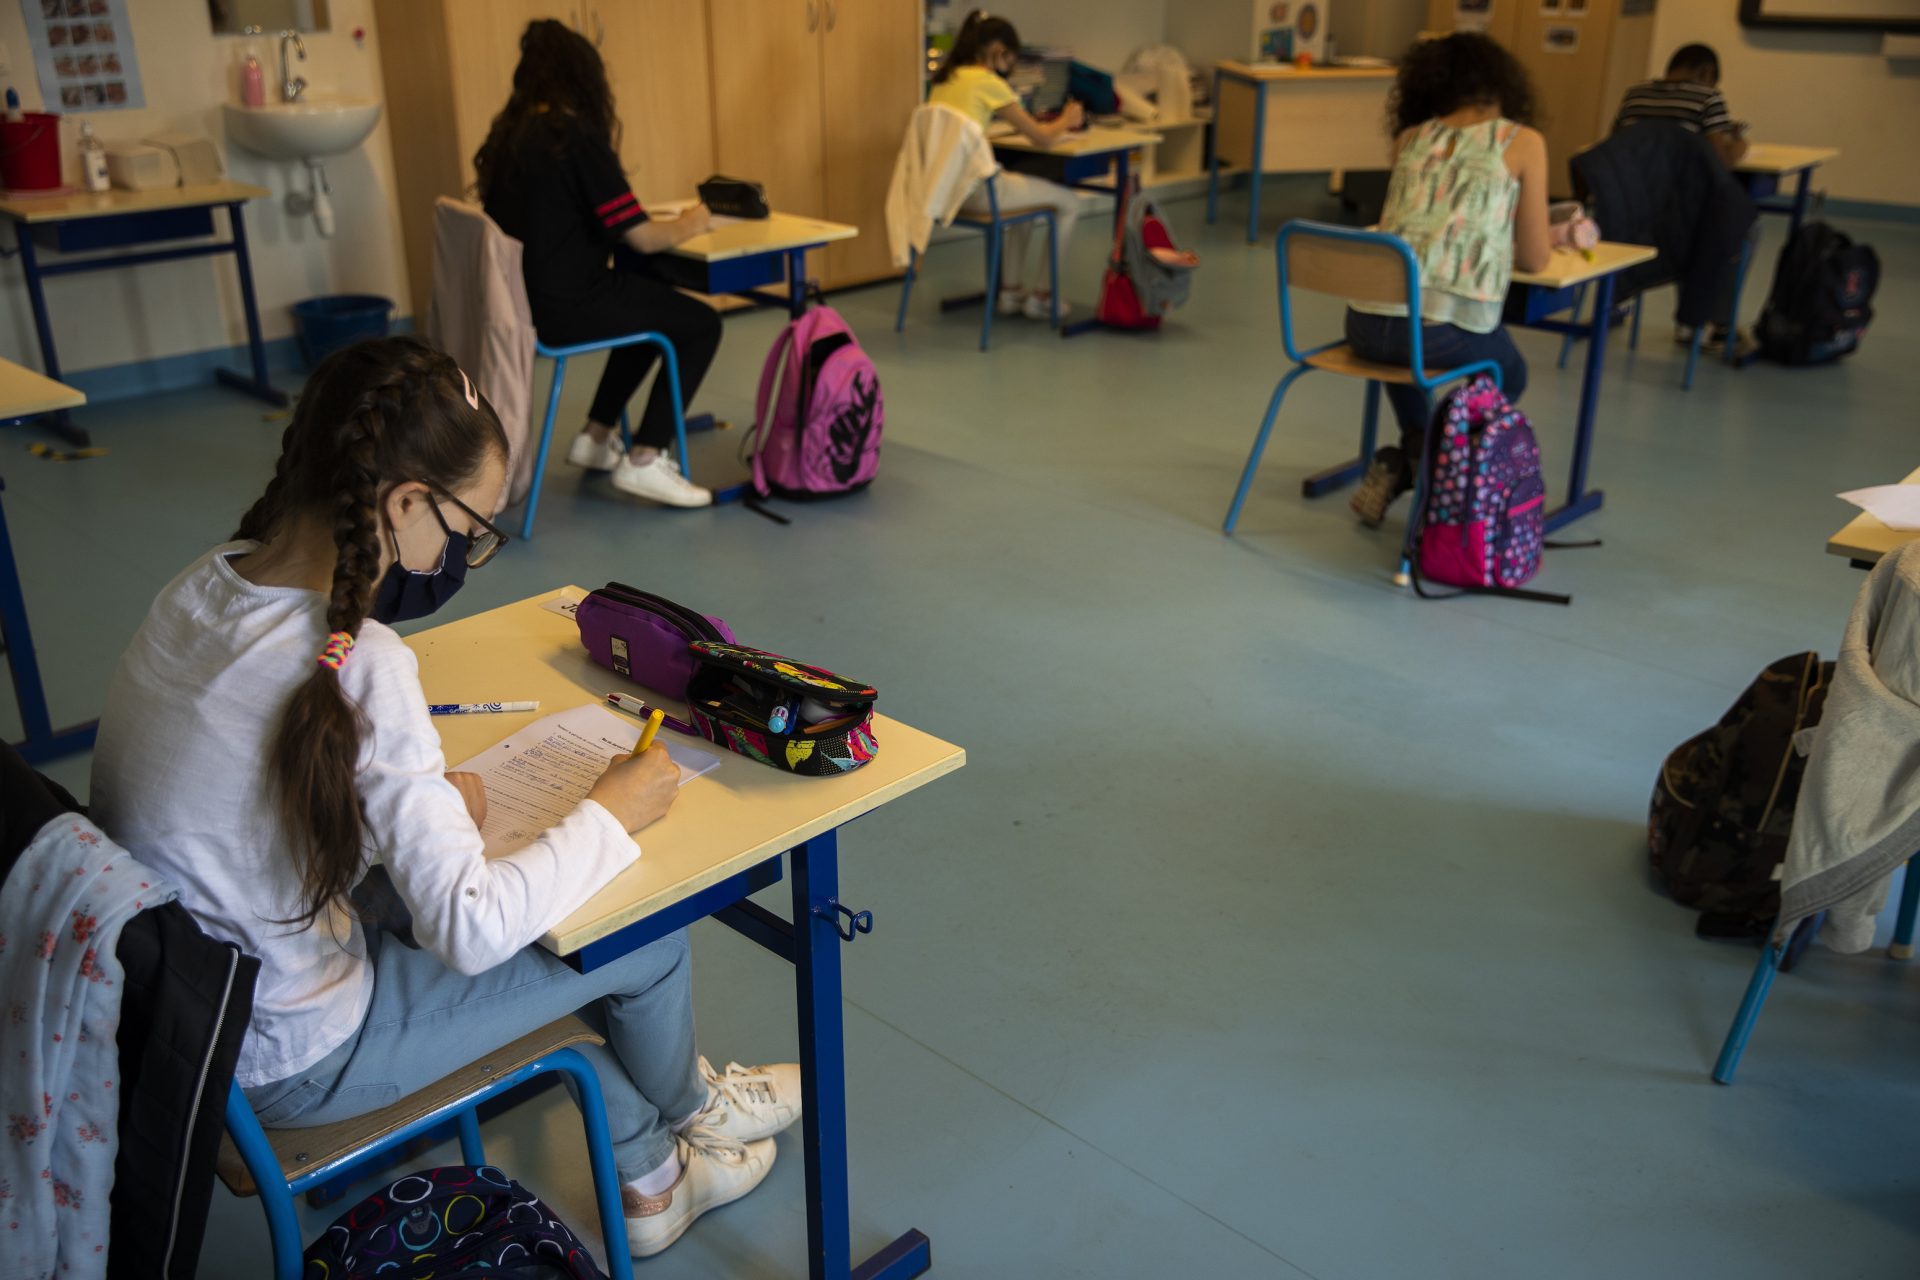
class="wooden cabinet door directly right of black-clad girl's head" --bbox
[588,0,714,203]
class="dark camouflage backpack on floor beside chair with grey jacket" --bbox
[1647,652,1834,938]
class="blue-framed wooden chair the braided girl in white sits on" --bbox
[217,1017,634,1280]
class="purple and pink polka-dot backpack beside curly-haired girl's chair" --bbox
[1413,374,1571,604]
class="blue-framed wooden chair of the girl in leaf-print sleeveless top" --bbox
[1225,219,1500,585]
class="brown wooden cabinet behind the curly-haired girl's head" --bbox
[1427,0,1653,196]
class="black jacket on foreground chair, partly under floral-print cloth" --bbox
[0,743,259,1280]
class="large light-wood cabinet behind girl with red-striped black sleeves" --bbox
[374,0,925,312]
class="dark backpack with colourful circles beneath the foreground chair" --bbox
[301,1165,607,1280]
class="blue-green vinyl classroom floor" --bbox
[0,180,1920,1280]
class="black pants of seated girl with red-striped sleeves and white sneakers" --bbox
[530,251,720,449]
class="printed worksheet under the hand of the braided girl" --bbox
[457,702,720,856]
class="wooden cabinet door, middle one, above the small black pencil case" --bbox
[710,0,826,217]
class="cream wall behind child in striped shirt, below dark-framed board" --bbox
[1647,0,1920,205]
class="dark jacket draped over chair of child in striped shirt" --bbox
[1571,123,1759,324]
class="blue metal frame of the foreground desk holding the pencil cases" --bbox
[563,829,933,1280]
